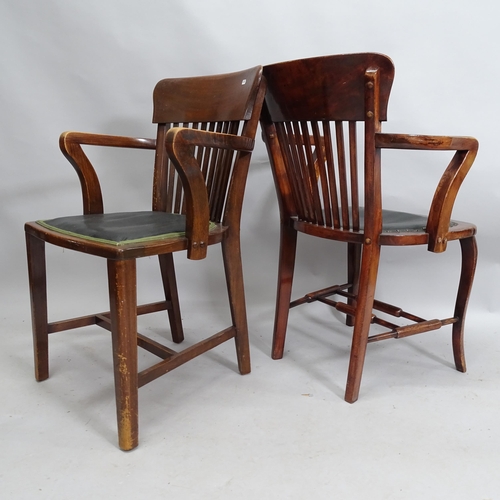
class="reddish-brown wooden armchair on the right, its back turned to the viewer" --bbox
[261,54,478,403]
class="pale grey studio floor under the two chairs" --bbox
[0,280,500,500]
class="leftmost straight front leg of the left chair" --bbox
[26,233,49,382]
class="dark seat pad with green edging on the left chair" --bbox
[37,211,206,245]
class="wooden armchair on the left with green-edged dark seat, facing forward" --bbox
[25,67,265,450]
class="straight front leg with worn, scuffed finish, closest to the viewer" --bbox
[108,260,139,451]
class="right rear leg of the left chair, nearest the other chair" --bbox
[222,235,251,375]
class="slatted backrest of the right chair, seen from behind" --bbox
[261,53,394,231]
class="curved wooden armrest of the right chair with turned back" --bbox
[375,133,479,252]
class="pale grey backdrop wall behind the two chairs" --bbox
[0,0,500,348]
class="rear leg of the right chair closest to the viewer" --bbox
[345,242,380,403]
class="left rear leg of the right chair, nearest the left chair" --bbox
[272,224,297,359]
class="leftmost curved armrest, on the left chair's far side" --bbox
[59,132,156,214]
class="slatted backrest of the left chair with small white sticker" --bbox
[153,66,264,223]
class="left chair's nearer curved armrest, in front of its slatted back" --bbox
[165,127,255,260]
